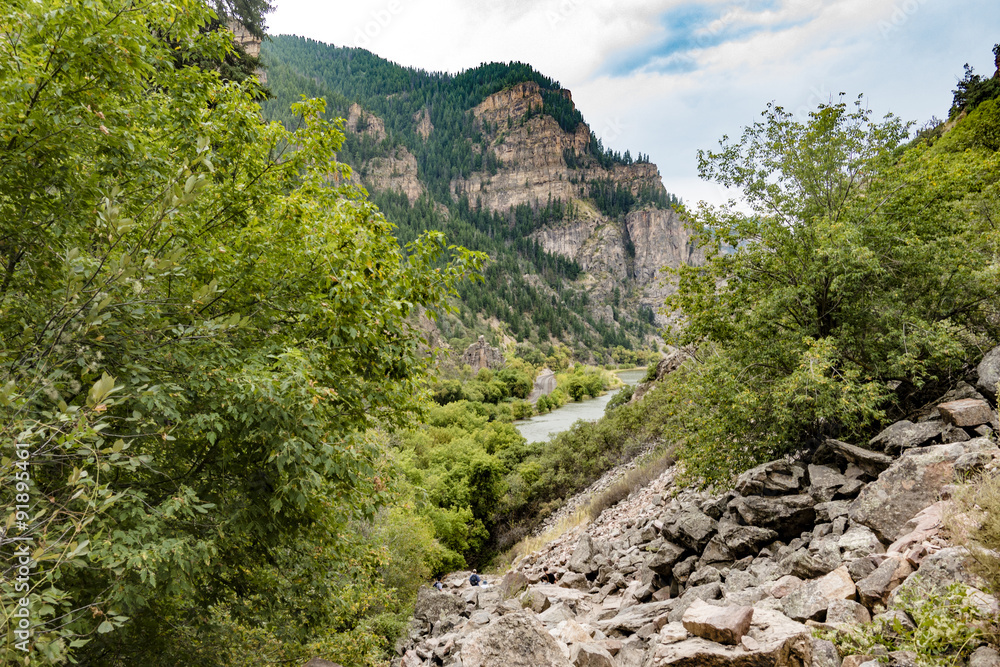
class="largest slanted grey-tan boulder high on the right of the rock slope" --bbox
[850,438,992,543]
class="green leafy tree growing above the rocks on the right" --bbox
[668,98,1000,477]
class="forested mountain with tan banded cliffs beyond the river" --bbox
[261,36,700,360]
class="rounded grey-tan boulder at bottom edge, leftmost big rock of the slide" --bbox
[462,612,572,667]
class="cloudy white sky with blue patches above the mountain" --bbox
[267,0,1000,203]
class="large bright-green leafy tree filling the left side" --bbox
[0,0,482,664]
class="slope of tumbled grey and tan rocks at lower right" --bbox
[394,348,1000,667]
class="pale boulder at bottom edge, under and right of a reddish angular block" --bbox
[645,609,812,667]
